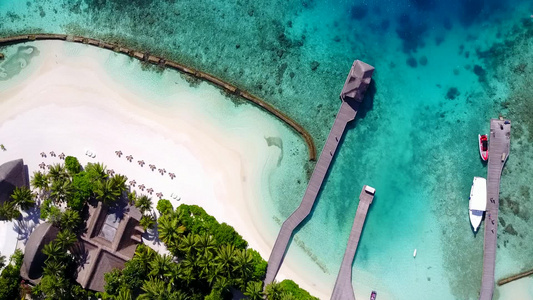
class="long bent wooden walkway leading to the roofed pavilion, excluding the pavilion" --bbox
[265,101,359,285]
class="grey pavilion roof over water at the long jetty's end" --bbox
[340,60,374,102]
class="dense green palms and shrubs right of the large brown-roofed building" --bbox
[101,199,317,300]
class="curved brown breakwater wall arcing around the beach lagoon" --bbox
[0,33,316,161]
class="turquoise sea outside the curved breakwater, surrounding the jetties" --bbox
[0,0,533,299]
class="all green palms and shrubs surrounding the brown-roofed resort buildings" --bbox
[4,156,316,300]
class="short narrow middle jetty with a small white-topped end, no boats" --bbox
[331,185,375,300]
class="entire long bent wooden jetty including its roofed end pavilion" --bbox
[265,60,374,286]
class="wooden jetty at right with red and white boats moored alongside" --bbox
[479,118,511,300]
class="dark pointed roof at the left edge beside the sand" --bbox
[0,159,29,203]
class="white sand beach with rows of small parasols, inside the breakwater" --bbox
[0,42,329,298]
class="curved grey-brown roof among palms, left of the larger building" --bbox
[20,223,59,284]
